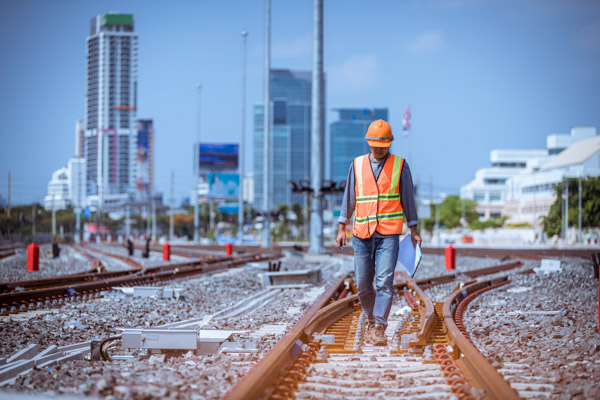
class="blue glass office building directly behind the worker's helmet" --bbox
[329,108,389,205]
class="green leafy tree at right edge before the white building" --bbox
[542,177,600,236]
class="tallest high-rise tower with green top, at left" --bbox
[85,13,138,208]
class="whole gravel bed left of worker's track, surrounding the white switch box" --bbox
[0,253,341,399]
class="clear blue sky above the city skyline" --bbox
[0,0,600,203]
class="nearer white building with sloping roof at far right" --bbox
[503,127,600,226]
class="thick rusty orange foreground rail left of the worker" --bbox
[223,274,348,400]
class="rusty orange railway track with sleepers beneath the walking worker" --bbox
[224,261,531,400]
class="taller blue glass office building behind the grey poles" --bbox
[254,69,312,209]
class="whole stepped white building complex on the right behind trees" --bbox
[460,127,600,226]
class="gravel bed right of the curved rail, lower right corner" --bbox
[464,258,600,399]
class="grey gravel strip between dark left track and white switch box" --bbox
[0,270,262,357]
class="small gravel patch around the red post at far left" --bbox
[0,245,92,282]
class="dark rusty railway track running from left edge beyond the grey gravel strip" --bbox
[0,249,281,315]
